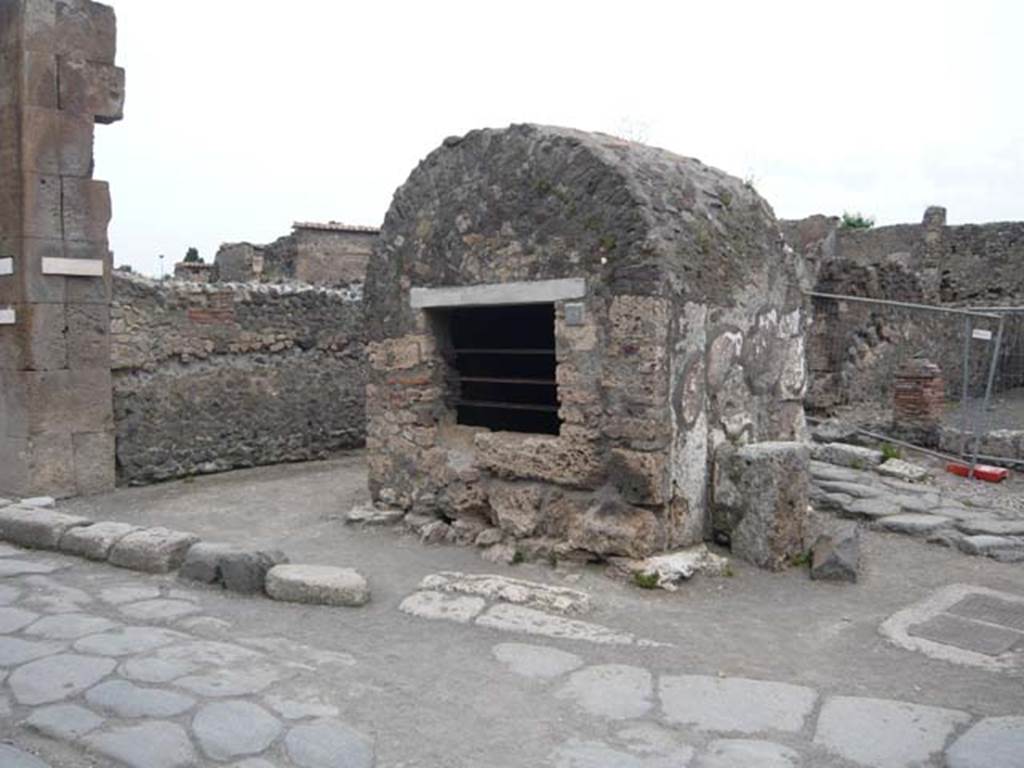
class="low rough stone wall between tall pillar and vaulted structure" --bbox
[112,274,366,483]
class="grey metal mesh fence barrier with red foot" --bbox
[807,292,1024,465]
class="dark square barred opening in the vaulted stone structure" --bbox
[447,304,560,434]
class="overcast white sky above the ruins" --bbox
[96,0,1024,273]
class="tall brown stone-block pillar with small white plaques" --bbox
[0,0,124,497]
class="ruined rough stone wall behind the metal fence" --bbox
[782,207,1024,420]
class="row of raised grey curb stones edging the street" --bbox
[0,497,370,606]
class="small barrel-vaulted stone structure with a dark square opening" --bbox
[366,125,805,556]
